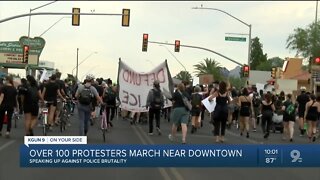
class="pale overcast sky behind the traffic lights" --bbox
[0,1,316,80]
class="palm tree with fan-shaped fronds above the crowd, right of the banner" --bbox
[193,58,224,81]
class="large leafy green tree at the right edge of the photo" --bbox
[286,22,320,58]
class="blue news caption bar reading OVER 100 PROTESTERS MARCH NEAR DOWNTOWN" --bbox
[20,136,320,168]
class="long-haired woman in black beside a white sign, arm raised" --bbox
[209,81,231,142]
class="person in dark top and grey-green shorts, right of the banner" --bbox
[169,83,190,144]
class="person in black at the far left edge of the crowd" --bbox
[0,76,18,138]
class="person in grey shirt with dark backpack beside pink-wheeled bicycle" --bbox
[75,74,103,136]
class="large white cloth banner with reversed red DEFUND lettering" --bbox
[118,60,173,112]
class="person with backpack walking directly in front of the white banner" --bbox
[146,80,164,135]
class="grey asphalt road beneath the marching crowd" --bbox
[0,108,320,180]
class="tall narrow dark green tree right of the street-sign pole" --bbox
[250,37,267,70]
